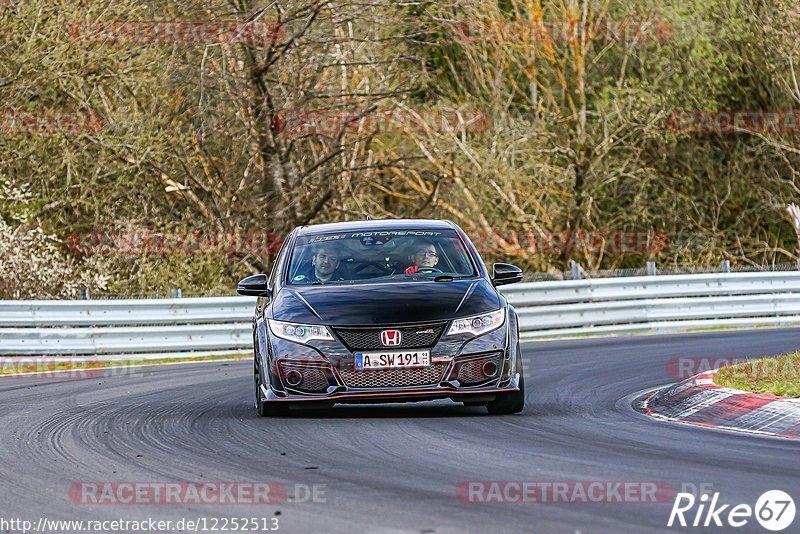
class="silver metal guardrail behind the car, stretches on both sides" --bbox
[0,271,800,355]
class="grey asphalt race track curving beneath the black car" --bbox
[0,329,800,534]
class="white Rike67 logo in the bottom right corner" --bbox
[667,490,796,532]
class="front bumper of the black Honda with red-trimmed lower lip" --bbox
[257,313,520,404]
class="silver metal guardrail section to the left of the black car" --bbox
[0,297,255,355]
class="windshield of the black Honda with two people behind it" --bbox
[287,230,477,285]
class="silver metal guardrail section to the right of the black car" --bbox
[504,271,800,339]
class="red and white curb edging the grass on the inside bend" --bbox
[642,370,800,440]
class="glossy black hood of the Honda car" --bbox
[272,278,501,326]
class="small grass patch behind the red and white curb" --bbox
[714,352,800,398]
